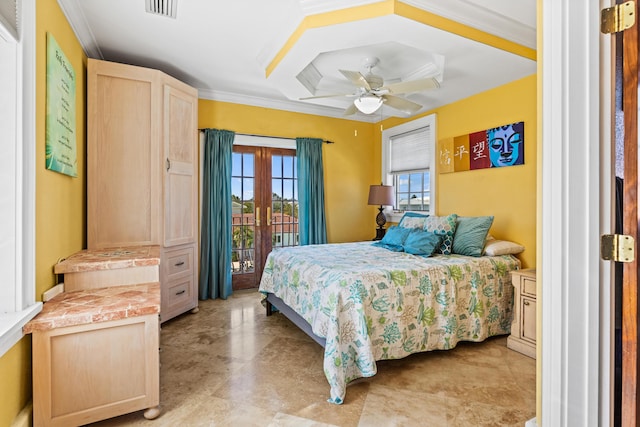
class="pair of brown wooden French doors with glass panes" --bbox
[231,145,299,290]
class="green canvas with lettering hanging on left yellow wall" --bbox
[45,33,78,177]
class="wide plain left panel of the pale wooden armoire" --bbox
[87,59,162,249]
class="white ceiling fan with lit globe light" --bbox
[300,58,440,116]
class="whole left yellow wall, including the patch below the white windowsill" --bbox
[0,0,87,426]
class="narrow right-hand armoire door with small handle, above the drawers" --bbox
[161,83,198,247]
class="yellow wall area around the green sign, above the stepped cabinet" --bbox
[36,0,87,296]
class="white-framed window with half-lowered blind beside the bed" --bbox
[382,114,436,222]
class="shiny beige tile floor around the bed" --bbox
[86,291,536,427]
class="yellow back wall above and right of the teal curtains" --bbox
[198,99,380,243]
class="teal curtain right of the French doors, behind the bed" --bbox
[296,138,327,245]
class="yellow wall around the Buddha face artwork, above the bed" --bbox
[375,75,537,268]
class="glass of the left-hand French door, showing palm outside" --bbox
[231,153,256,274]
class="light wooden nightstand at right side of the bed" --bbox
[507,269,536,359]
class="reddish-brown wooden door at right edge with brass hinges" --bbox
[620,3,640,427]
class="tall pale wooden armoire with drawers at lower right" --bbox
[87,59,199,321]
